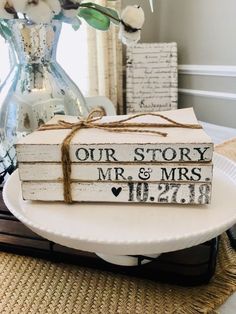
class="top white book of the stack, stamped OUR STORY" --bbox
[17,108,213,164]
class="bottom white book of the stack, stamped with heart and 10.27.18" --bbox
[22,181,211,205]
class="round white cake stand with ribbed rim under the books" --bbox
[3,154,236,265]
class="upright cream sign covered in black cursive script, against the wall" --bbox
[126,43,178,113]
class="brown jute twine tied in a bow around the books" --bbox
[38,109,202,204]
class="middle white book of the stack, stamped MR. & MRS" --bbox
[19,162,213,182]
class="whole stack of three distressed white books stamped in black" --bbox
[17,109,213,204]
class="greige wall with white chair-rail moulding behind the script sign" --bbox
[126,0,236,128]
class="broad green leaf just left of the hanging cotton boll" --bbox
[78,8,110,31]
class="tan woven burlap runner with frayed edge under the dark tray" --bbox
[0,139,236,314]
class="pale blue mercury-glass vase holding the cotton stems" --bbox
[0,20,89,183]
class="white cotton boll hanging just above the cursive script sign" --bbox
[119,6,145,46]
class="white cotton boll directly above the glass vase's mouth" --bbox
[11,0,61,23]
